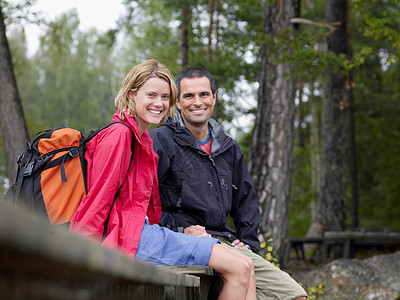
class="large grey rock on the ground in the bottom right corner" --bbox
[292,251,400,300]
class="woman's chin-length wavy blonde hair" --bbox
[115,59,178,122]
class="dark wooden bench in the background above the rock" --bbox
[283,231,400,266]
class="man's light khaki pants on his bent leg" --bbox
[214,236,307,300]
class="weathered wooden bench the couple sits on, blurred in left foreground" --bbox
[0,199,213,300]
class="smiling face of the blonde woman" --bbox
[131,77,171,133]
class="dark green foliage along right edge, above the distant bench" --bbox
[344,0,400,230]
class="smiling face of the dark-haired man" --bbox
[177,77,216,127]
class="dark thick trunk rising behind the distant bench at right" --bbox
[316,0,347,231]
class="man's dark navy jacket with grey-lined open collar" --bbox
[150,112,261,251]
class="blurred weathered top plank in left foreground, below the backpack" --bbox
[0,200,200,288]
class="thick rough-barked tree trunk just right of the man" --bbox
[249,1,297,260]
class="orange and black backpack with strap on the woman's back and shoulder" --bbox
[6,122,134,238]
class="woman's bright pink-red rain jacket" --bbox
[70,111,161,258]
